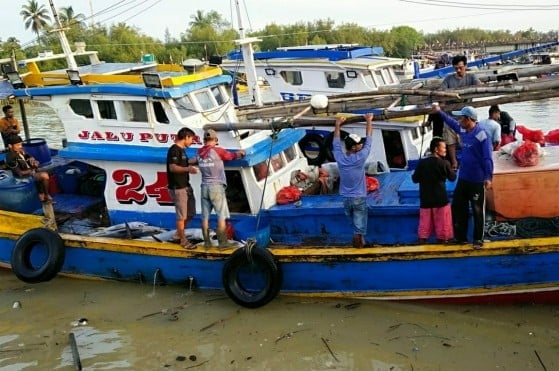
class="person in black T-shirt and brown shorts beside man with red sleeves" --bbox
[167,128,198,249]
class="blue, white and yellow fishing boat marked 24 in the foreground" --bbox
[0,2,559,308]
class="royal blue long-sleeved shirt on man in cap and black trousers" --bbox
[439,111,493,183]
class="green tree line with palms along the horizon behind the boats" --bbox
[0,0,557,67]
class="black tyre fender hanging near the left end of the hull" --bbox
[12,228,66,283]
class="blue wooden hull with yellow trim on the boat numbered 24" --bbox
[0,211,559,302]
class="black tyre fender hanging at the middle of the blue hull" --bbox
[221,246,282,308]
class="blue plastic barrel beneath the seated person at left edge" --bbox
[0,170,41,213]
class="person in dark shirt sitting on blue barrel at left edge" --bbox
[6,134,52,202]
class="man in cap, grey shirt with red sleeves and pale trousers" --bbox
[196,129,245,248]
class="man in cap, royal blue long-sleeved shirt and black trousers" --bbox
[433,104,493,249]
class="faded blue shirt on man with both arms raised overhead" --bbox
[332,137,373,197]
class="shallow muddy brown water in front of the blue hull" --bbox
[0,270,559,371]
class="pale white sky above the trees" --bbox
[0,0,559,44]
